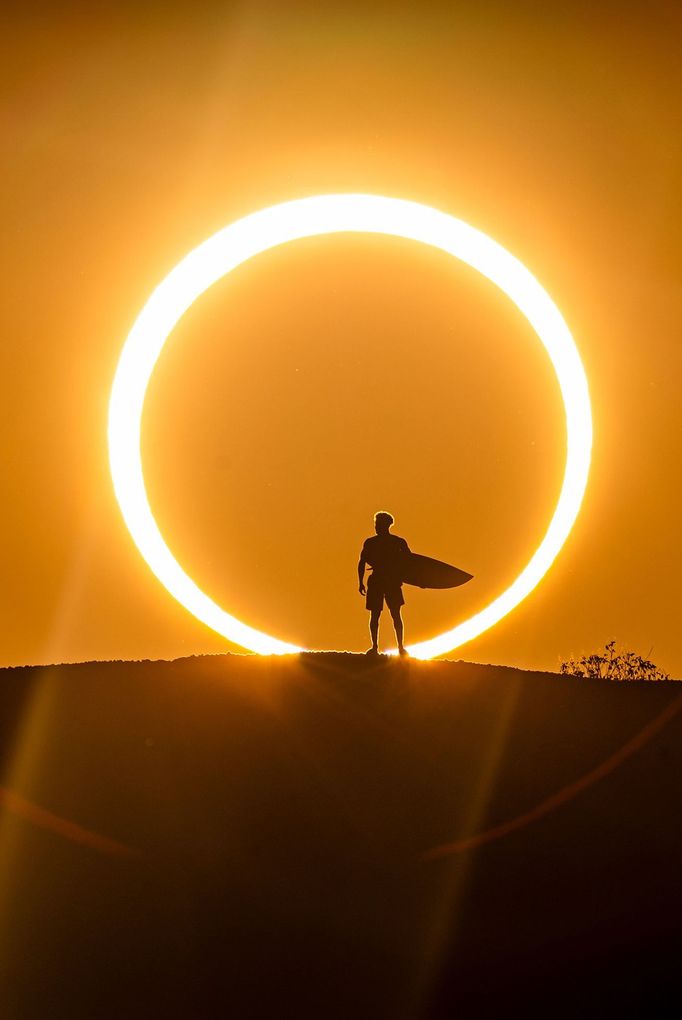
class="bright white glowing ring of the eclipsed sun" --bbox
[109,195,592,659]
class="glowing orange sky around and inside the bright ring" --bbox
[0,3,682,676]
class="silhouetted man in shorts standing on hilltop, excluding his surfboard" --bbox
[358,510,410,655]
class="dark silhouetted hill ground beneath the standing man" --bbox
[0,654,682,1020]
